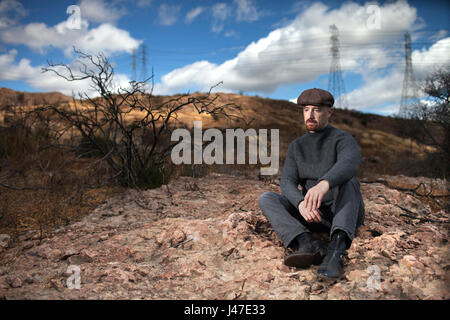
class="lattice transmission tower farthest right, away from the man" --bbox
[398,32,419,118]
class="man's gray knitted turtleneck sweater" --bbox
[280,124,361,208]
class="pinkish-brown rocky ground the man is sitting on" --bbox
[0,174,450,299]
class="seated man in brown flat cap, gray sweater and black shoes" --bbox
[259,88,365,278]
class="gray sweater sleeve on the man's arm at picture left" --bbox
[280,143,304,208]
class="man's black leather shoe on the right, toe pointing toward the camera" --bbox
[317,230,348,279]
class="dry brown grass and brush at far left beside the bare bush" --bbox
[0,112,123,240]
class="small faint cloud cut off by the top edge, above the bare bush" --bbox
[80,0,126,24]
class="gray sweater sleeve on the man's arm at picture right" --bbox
[319,134,361,188]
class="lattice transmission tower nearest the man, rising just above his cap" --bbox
[328,24,348,109]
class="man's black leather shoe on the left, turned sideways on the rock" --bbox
[284,232,324,268]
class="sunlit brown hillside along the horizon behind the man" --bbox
[0,88,434,176]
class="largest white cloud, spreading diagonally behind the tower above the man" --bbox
[155,1,417,93]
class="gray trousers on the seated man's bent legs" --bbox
[258,177,365,248]
